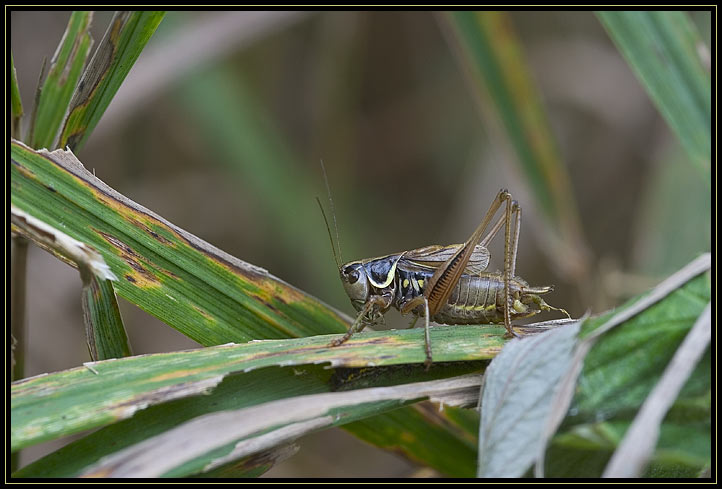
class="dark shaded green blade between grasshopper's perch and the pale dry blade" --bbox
[13,362,480,477]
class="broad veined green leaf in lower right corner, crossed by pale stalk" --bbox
[545,273,711,477]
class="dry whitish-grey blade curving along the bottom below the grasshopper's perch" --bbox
[82,375,480,477]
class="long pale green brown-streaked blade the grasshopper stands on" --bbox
[11,326,506,450]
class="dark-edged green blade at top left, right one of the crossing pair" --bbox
[58,11,165,150]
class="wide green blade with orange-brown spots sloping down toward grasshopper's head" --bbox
[11,142,347,346]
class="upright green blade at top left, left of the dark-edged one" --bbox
[28,12,93,149]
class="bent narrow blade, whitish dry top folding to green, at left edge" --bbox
[11,206,130,360]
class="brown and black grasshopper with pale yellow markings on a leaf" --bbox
[318,185,569,369]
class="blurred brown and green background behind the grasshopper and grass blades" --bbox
[10,11,711,477]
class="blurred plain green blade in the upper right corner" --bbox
[597,11,712,175]
